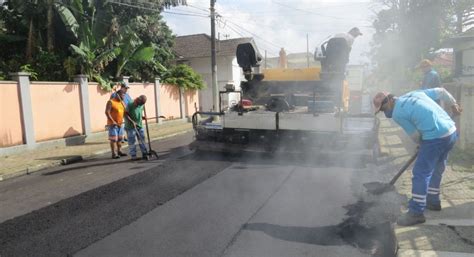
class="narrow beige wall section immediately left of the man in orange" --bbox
[89,82,110,132]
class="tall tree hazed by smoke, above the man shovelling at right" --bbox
[371,0,453,90]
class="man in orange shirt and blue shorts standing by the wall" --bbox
[105,91,127,159]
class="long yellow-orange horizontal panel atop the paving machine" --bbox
[263,67,321,81]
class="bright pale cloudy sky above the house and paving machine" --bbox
[163,0,375,64]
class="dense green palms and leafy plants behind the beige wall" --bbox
[0,0,186,87]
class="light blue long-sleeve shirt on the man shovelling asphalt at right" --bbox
[392,88,456,141]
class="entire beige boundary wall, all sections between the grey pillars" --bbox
[0,81,199,147]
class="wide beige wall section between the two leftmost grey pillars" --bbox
[30,82,83,141]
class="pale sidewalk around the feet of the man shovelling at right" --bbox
[380,119,474,257]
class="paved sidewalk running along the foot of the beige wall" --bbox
[0,120,192,181]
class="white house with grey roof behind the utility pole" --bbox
[174,34,255,111]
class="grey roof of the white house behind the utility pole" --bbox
[173,34,258,59]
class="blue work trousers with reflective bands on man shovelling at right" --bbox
[408,132,457,214]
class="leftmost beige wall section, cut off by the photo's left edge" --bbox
[0,81,23,147]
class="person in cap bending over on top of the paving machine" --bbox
[321,27,362,73]
